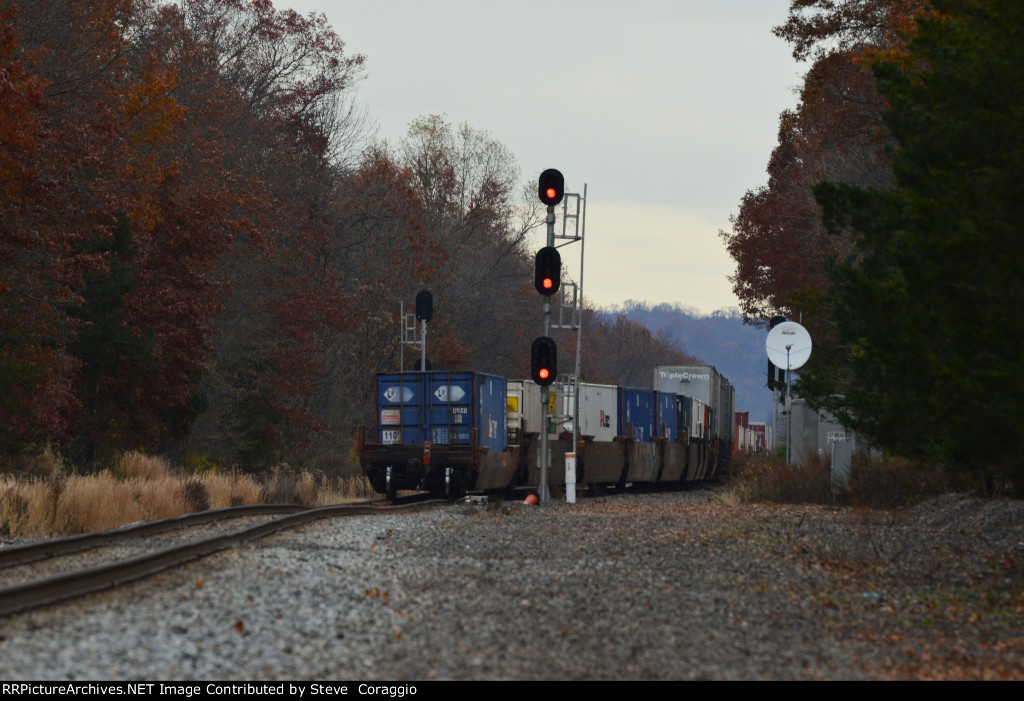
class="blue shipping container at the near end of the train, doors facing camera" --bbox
[377,370,507,452]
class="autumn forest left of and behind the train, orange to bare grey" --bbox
[0,0,691,472]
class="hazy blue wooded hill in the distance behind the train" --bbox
[606,301,771,422]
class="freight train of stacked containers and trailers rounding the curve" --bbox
[356,365,753,499]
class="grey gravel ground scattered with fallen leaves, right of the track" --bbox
[0,490,1024,682]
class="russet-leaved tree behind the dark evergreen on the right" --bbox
[722,0,925,337]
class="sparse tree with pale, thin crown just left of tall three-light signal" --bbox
[400,115,543,375]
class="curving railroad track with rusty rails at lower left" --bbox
[0,498,447,616]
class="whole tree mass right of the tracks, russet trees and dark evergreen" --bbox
[722,0,1024,494]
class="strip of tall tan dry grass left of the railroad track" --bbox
[0,452,374,537]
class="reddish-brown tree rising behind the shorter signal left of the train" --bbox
[290,147,465,454]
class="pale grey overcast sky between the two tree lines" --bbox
[284,0,804,313]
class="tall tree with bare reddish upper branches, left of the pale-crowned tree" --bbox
[168,0,365,470]
